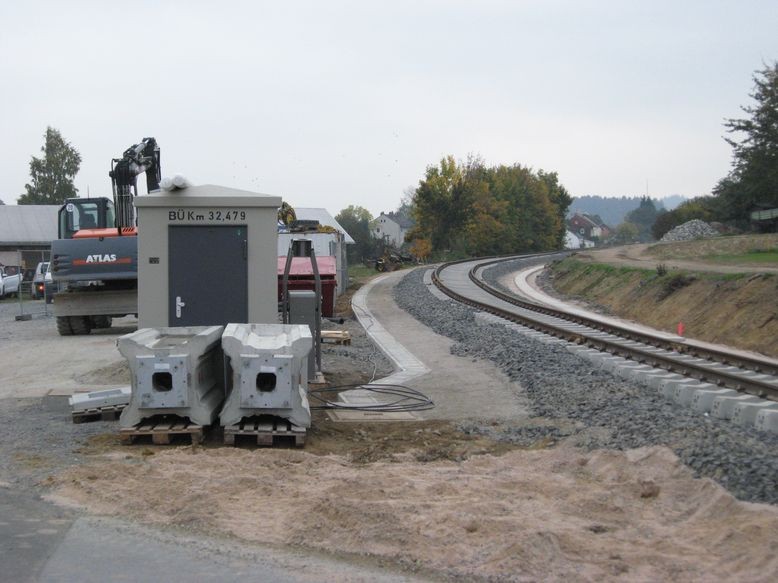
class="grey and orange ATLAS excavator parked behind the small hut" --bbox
[51,138,162,336]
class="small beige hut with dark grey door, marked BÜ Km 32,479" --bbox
[135,185,281,328]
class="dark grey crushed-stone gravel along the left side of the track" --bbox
[395,260,778,504]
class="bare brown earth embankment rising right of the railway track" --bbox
[539,236,778,358]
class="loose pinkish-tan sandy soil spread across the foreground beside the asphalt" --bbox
[52,442,778,581]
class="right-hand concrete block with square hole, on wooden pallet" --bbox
[219,324,313,427]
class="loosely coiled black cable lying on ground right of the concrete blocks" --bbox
[308,383,435,413]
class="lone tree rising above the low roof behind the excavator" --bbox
[18,127,81,204]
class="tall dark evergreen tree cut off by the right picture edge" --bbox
[714,61,778,224]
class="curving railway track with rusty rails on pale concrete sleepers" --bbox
[432,254,778,401]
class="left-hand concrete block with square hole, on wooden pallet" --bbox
[116,326,224,427]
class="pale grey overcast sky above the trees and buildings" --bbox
[0,0,778,215]
